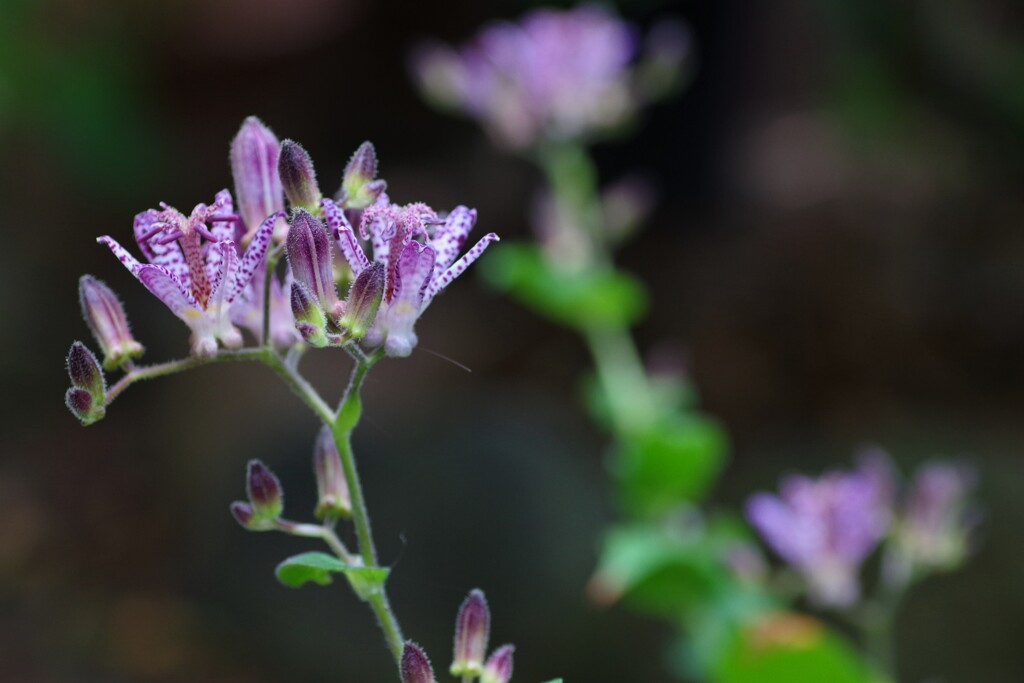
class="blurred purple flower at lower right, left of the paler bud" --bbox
[746,461,892,607]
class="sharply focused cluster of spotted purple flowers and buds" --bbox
[66,117,498,424]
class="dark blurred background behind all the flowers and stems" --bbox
[0,0,1024,683]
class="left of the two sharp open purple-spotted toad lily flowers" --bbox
[96,189,283,357]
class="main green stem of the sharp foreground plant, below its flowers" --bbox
[328,352,403,665]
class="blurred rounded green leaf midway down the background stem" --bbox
[612,413,727,516]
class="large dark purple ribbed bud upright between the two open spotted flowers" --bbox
[288,209,342,321]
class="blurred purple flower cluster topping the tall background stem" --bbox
[412,5,685,148]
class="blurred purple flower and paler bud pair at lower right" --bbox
[746,450,973,607]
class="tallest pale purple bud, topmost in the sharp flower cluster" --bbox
[231,116,287,244]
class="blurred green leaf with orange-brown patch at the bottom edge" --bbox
[713,612,873,683]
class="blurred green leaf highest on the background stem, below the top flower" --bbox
[482,244,647,329]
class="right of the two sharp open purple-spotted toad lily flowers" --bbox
[321,195,498,357]
